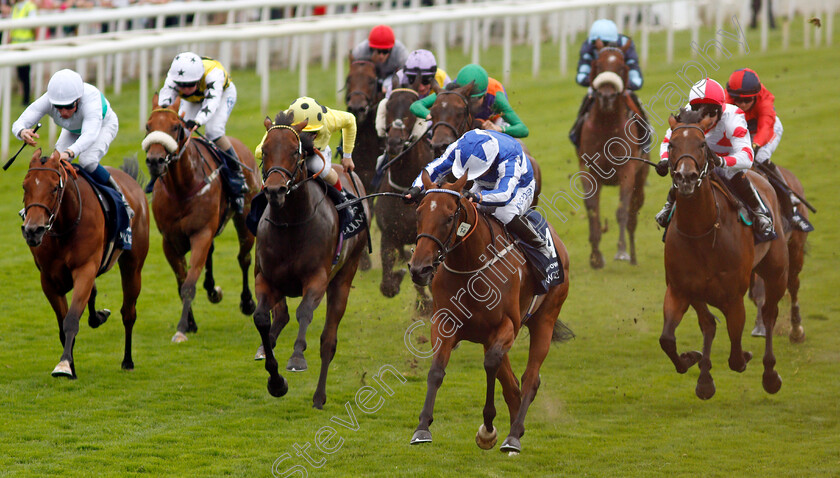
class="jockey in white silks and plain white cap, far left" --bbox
[12,69,134,244]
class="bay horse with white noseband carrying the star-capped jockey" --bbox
[143,94,261,343]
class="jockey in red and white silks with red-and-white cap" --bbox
[656,78,776,240]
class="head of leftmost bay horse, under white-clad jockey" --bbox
[20,148,70,247]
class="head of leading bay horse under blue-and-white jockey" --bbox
[408,170,469,286]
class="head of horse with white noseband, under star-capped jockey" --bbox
[142,93,189,177]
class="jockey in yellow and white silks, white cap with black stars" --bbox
[157,51,247,212]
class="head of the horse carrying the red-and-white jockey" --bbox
[668,109,715,196]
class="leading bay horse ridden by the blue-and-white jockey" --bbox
[409,171,569,453]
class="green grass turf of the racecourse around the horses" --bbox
[0,15,840,477]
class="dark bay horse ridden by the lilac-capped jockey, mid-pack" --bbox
[374,88,433,313]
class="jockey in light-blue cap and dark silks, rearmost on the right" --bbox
[569,18,651,150]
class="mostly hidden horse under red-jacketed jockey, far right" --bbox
[750,165,808,343]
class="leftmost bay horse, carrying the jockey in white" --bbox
[21,148,149,379]
